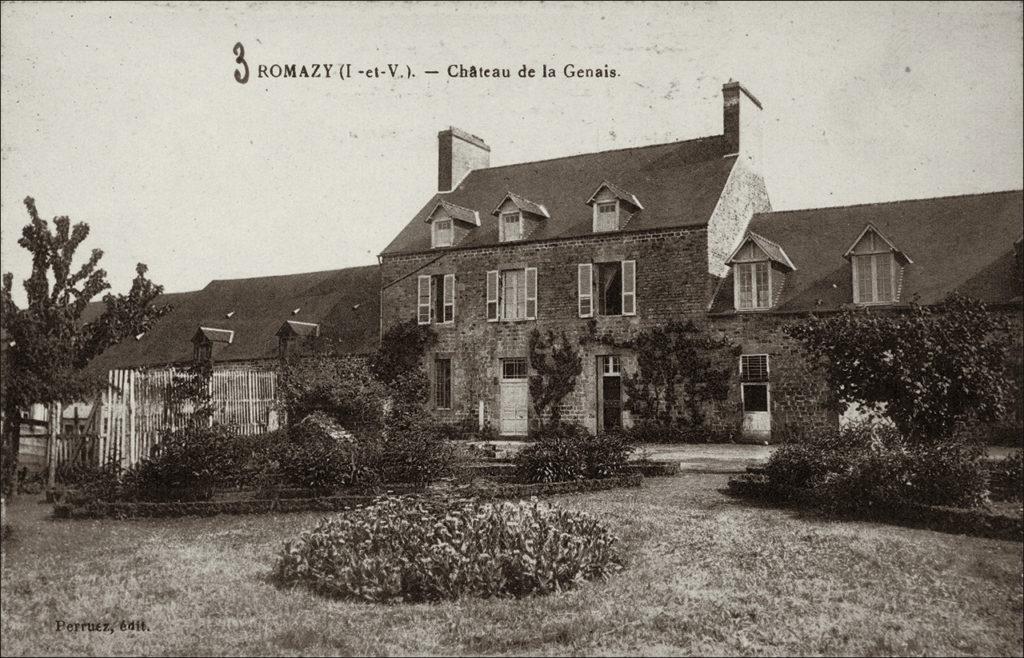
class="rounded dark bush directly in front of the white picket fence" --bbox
[122,426,242,500]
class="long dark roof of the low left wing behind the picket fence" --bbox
[83,265,380,371]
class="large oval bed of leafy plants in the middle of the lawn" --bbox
[274,497,622,602]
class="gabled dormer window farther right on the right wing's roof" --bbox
[843,224,912,305]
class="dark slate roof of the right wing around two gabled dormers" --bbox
[711,189,1024,313]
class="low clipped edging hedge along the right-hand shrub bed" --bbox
[729,475,1024,541]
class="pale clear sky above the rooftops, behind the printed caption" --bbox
[0,2,1024,299]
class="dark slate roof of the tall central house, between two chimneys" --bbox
[382,135,736,256]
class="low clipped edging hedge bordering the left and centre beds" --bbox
[53,475,643,519]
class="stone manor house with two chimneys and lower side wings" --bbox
[68,77,1024,448]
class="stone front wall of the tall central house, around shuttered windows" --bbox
[382,227,709,430]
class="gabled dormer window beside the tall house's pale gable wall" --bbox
[726,231,797,311]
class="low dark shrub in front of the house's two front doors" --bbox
[516,424,633,482]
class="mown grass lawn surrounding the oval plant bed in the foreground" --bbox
[0,474,1024,656]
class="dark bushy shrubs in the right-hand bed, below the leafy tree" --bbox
[764,424,987,511]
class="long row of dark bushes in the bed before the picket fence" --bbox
[60,412,452,502]
